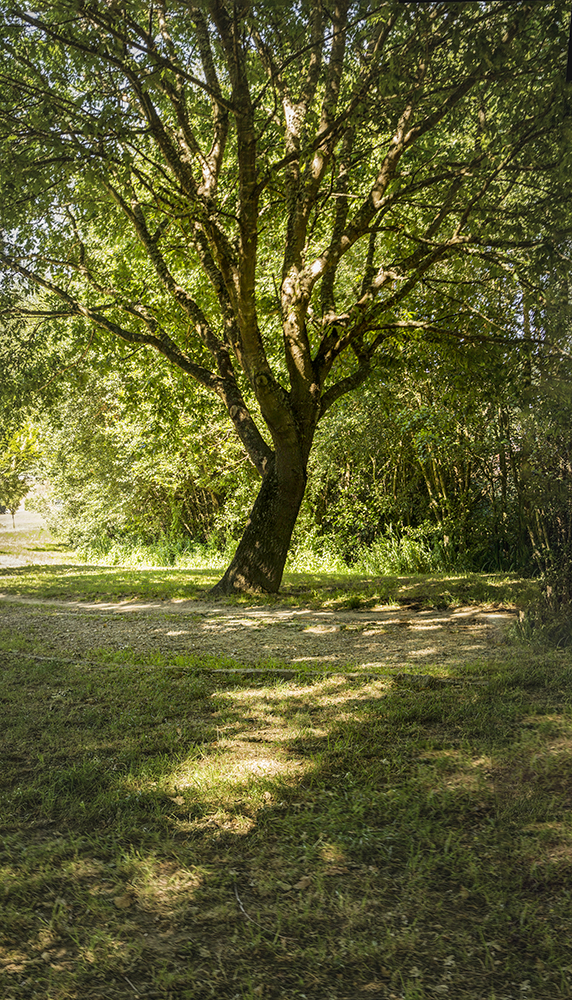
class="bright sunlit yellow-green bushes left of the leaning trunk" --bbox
[35,359,260,564]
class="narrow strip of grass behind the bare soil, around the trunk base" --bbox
[0,512,538,609]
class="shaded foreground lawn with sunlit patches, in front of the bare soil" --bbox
[0,655,572,1000]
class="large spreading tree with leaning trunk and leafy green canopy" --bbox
[0,0,567,593]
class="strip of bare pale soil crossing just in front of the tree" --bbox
[0,595,516,672]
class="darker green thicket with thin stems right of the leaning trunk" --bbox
[295,334,533,571]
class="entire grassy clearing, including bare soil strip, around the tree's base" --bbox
[0,522,572,1000]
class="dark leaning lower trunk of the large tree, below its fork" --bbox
[210,454,306,597]
